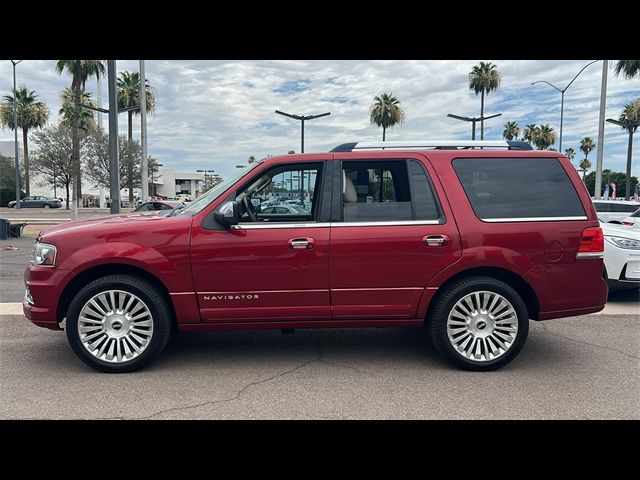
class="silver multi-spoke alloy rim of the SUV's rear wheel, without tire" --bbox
[447,291,518,362]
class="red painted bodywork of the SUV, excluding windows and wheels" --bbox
[24,150,607,331]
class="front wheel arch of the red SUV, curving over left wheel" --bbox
[56,263,176,324]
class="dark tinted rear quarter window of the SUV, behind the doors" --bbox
[453,158,585,220]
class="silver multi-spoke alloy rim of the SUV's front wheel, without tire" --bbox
[78,290,153,363]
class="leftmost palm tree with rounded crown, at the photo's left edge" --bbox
[0,87,49,195]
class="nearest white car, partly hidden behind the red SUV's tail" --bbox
[600,222,640,290]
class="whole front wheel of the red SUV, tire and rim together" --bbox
[66,275,171,373]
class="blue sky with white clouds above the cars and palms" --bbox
[0,59,640,177]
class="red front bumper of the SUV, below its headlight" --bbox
[22,265,73,330]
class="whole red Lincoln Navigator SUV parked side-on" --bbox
[24,141,607,372]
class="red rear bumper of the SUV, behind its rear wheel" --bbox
[525,259,609,320]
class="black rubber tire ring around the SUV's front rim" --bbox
[66,274,173,373]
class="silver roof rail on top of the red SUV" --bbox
[331,140,533,152]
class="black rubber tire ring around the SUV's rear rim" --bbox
[427,276,529,371]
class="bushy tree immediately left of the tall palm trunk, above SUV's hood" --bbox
[32,123,73,210]
